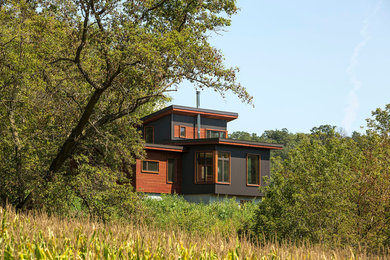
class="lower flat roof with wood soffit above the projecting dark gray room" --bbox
[165,138,283,150]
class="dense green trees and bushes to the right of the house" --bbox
[231,105,390,250]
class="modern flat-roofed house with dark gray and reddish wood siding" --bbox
[133,105,282,202]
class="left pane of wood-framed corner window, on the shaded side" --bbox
[196,152,214,183]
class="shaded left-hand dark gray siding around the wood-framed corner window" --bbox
[181,145,215,194]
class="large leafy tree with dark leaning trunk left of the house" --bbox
[0,0,251,213]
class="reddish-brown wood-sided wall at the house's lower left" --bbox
[135,151,182,194]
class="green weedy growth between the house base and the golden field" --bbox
[142,195,256,235]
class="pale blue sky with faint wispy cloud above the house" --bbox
[172,0,390,134]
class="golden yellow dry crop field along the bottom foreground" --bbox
[0,207,390,259]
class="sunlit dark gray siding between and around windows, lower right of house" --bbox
[215,145,270,196]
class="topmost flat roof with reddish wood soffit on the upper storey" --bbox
[141,105,238,123]
